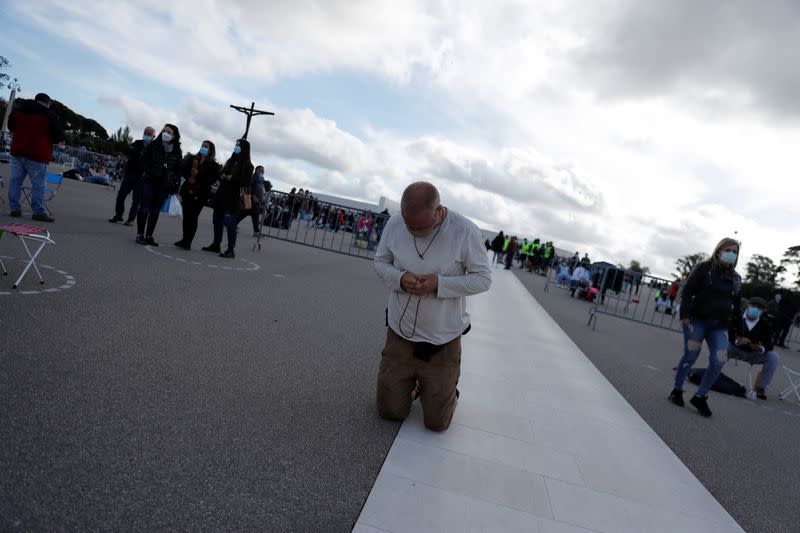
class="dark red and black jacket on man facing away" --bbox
[8,100,64,163]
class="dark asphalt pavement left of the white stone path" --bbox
[0,174,399,532]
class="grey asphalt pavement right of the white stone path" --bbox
[513,266,800,533]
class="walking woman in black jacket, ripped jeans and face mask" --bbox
[669,238,742,417]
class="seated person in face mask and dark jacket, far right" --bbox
[728,297,781,400]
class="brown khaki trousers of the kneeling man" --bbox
[377,328,461,431]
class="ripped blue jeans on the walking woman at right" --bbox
[675,318,728,396]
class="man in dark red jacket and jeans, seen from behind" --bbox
[8,93,64,222]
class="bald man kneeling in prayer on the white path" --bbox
[374,182,492,431]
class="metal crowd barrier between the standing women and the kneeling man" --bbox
[253,190,389,260]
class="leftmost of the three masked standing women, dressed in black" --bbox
[136,124,182,246]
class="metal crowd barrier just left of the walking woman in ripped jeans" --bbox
[584,267,683,332]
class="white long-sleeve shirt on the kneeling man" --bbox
[374,209,492,344]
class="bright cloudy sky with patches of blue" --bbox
[0,0,800,274]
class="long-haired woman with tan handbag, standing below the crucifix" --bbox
[203,139,253,259]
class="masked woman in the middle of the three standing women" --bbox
[175,140,219,250]
